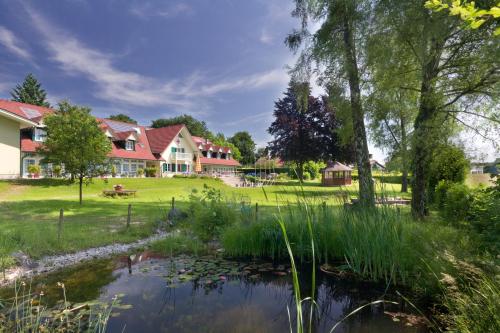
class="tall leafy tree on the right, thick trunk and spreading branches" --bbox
[374,0,500,218]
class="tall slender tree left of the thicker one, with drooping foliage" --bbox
[286,0,375,207]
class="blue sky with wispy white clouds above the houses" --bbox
[0,0,496,160]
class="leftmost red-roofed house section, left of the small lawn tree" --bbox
[0,99,54,178]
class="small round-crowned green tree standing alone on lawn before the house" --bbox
[40,102,111,203]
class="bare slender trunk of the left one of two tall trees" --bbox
[343,13,375,207]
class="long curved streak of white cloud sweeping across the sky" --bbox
[25,6,288,112]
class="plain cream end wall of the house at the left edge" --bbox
[0,116,21,178]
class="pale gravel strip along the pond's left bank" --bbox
[0,231,171,287]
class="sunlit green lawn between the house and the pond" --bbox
[0,178,406,257]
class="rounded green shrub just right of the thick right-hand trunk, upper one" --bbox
[429,145,469,188]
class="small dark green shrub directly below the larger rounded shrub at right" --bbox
[442,184,473,223]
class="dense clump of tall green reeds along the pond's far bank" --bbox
[222,200,430,284]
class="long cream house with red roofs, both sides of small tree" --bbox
[0,99,240,178]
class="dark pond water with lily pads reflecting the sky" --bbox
[4,253,426,333]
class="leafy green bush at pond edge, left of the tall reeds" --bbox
[189,184,236,242]
